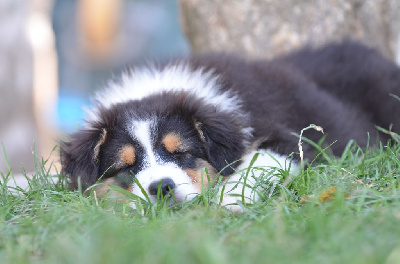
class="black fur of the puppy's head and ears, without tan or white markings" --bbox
[61,93,250,189]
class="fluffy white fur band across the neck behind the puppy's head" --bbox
[88,62,241,120]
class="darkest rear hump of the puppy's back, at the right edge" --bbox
[280,41,400,132]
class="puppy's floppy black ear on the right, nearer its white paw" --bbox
[195,115,250,176]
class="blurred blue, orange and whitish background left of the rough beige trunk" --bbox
[0,0,189,174]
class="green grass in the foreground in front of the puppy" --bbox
[0,138,400,264]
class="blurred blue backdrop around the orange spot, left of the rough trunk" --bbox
[52,0,190,132]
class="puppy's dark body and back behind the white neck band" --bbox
[188,41,400,158]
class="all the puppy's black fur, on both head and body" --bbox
[61,41,400,188]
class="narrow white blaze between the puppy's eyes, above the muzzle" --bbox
[129,120,157,166]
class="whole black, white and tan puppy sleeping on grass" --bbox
[61,42,400,211]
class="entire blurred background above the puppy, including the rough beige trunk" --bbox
[0,0,400,174]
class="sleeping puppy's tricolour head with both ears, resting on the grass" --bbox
[61,65,250,203]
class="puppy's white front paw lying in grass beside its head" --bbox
[218,149,300,213]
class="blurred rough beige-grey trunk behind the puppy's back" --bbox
[180,0,400,59]
